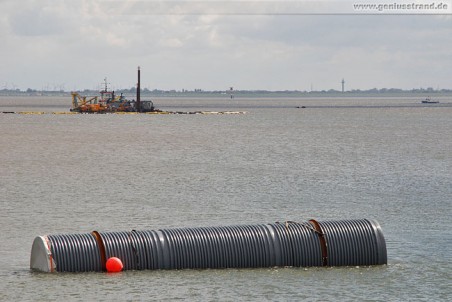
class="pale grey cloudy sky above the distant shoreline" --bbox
[0,0,452,91]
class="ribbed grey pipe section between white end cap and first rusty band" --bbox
[47,234,102,272]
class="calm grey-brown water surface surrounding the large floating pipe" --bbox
[0,97,452,301]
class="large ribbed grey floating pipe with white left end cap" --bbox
[30,219,387,272]
